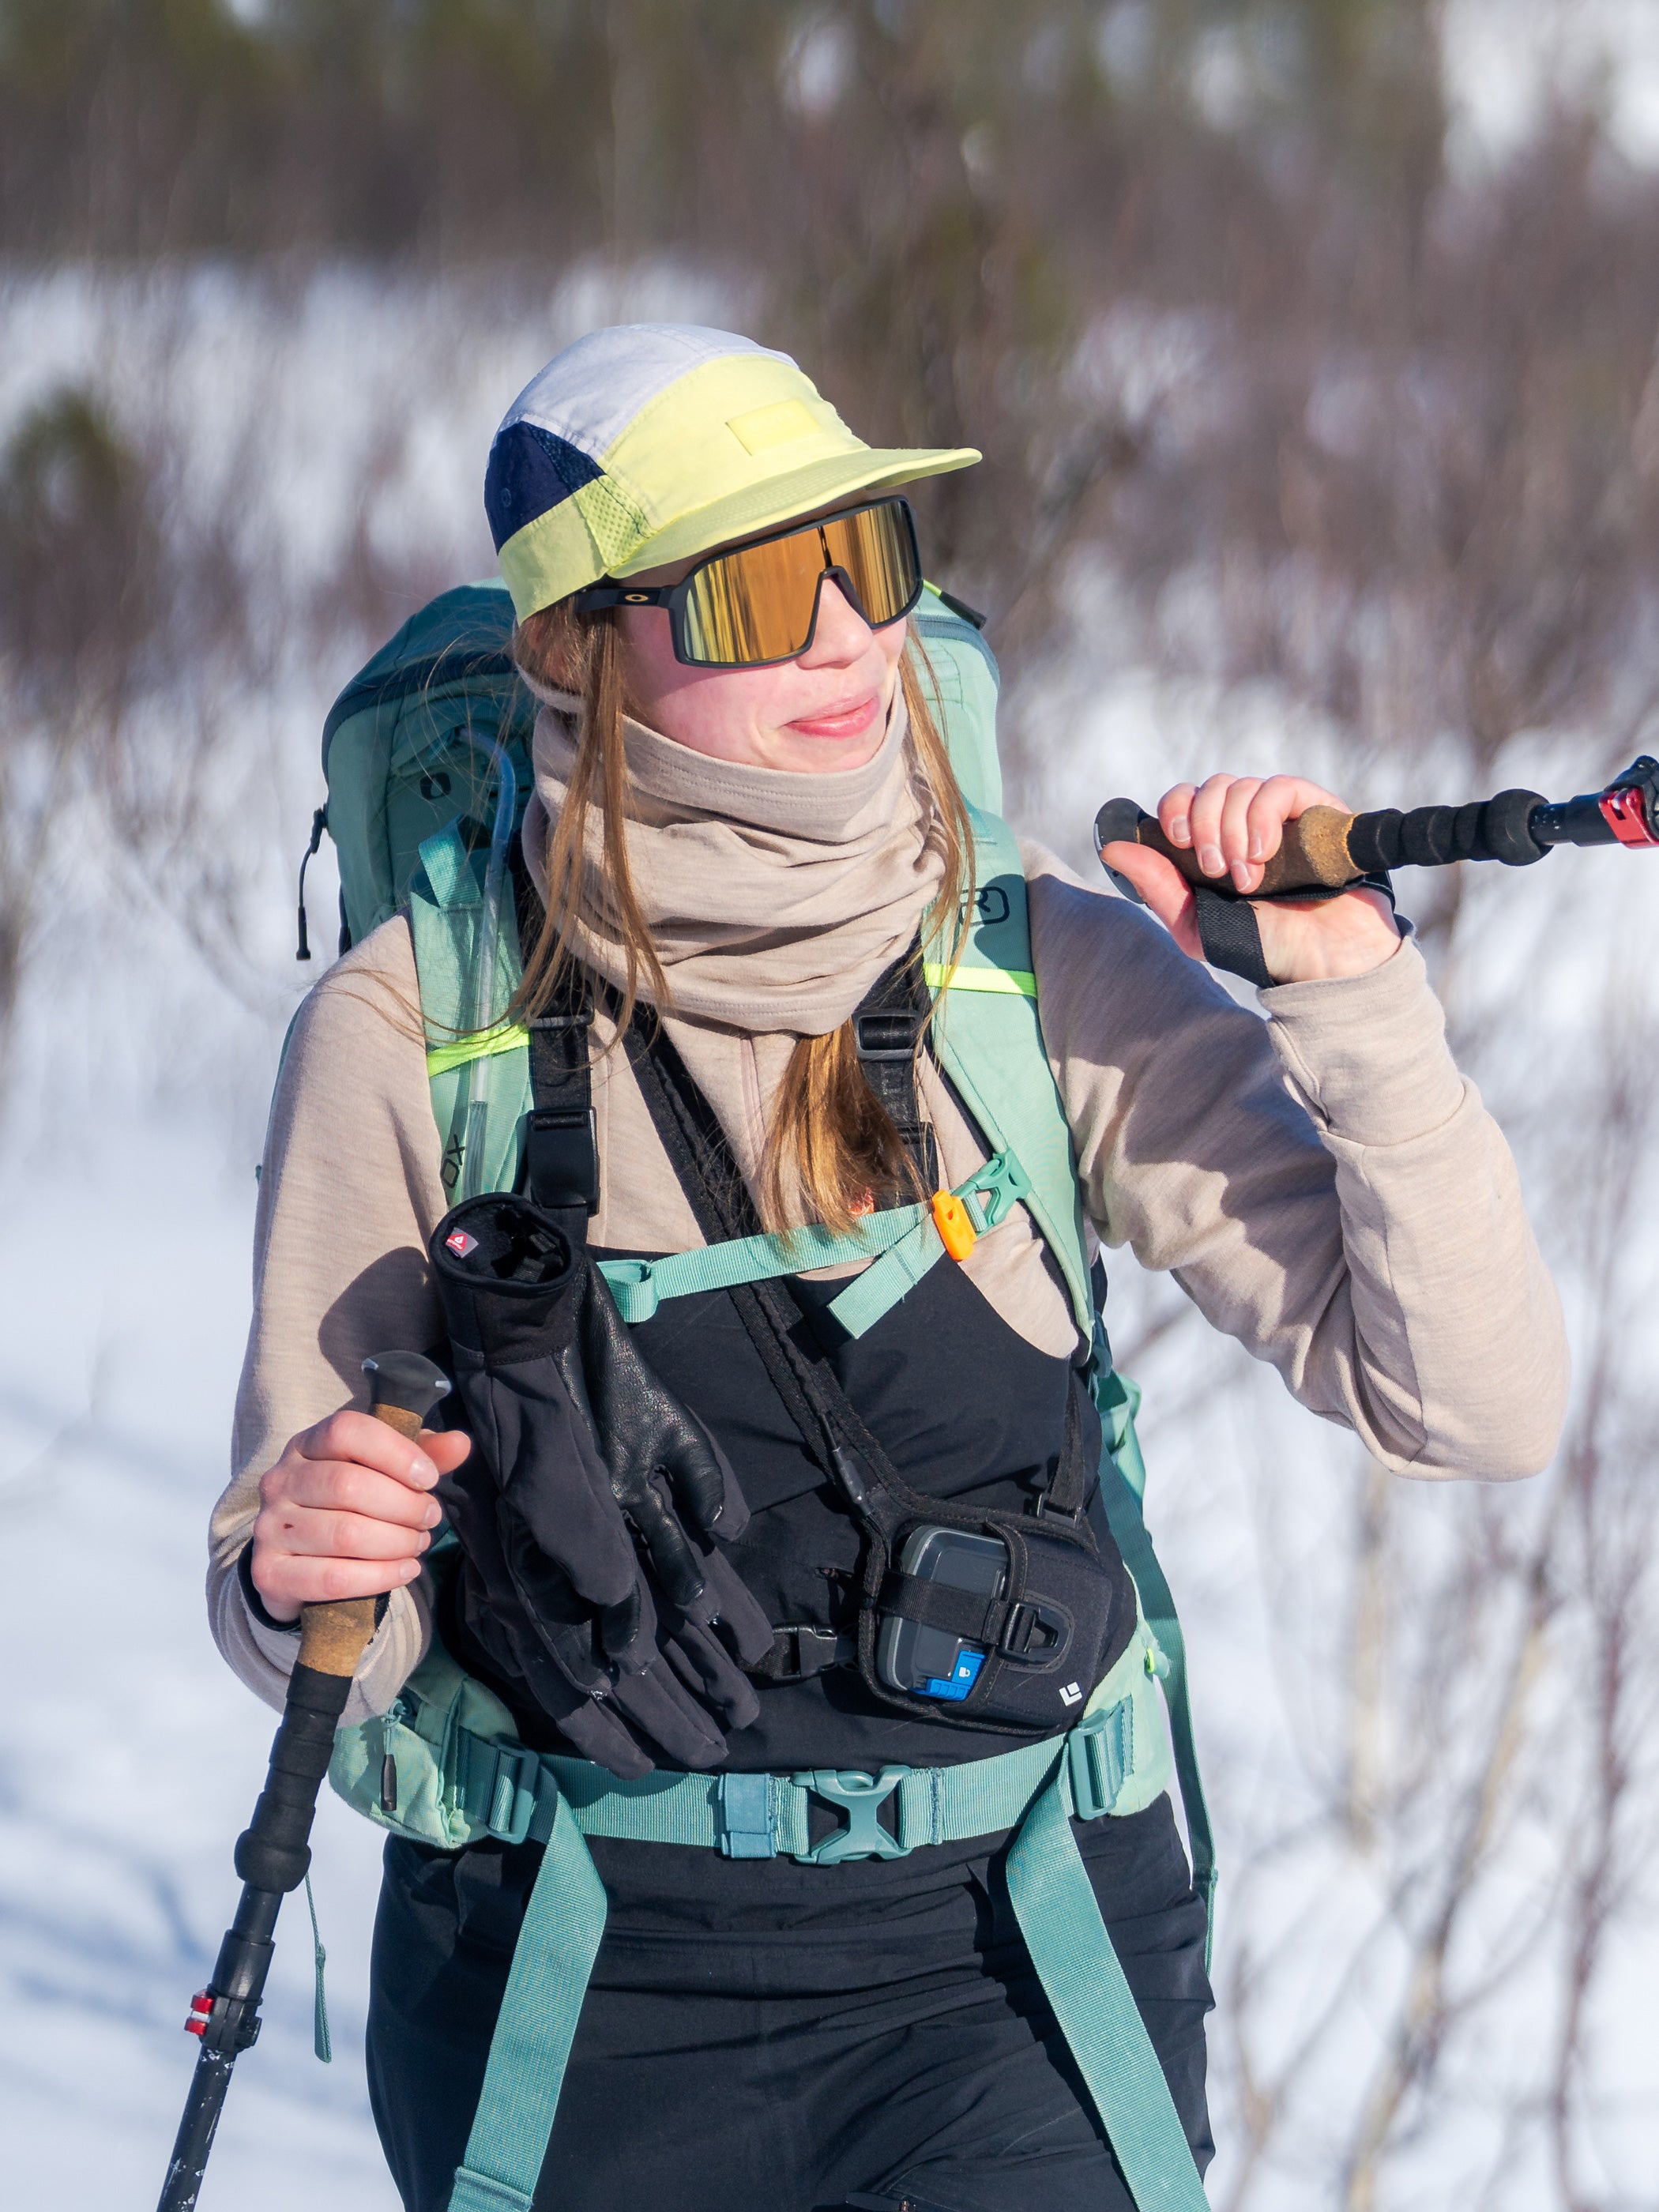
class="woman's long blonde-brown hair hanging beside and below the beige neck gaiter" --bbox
[514,604,973,1230]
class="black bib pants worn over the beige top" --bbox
[370,1266,1212,2212]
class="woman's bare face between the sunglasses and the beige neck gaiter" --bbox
[617,520,909,777]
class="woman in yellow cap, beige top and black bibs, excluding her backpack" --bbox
[213,325,1566,2212]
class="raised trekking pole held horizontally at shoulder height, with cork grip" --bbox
[1095,752,1659,898]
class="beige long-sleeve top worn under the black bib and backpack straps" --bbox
[208,847,1568,1719]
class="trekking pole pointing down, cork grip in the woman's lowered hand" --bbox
[157,1352,449,2212]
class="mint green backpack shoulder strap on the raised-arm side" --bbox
[924,805,1095,1343]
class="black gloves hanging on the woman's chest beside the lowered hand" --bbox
[431,1194,772,1774]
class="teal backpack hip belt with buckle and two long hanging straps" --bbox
[449,1623,1206,2212]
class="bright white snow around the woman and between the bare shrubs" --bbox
[0,25,1659,2185]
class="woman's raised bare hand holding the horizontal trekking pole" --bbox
[1101,777,1400,982]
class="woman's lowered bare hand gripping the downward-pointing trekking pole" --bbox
[252,1411,471,1621]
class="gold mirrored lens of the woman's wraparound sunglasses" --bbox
[681,500,923,668]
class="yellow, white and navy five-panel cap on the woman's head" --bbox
[484,323,980,622]
